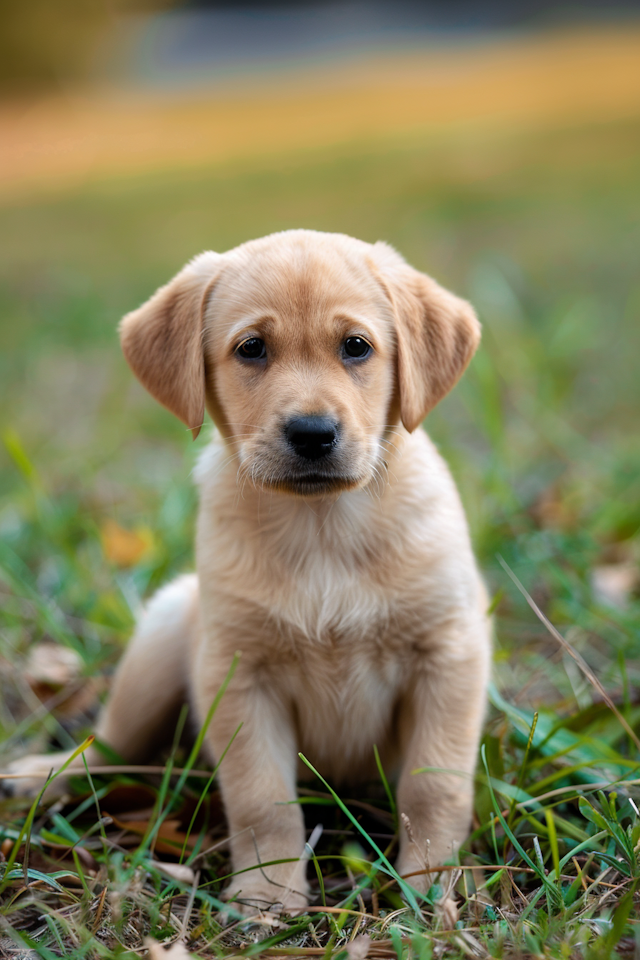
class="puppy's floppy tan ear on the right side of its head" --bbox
[376,244,480,432]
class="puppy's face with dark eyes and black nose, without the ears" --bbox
[204,236,395,496]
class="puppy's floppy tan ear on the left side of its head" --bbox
[119,253,222,440]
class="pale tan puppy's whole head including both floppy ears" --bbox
[120,230,480,496]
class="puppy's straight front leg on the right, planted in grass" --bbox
[397,620,490,892]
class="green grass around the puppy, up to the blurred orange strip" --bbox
[0,114,640,960]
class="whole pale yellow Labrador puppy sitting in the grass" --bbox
[6,230,490,913]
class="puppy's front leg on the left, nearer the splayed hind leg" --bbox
[194,652,309,915]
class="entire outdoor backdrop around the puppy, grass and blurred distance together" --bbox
[0,0,640,958]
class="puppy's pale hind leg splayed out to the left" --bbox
[2,574,198,797]
